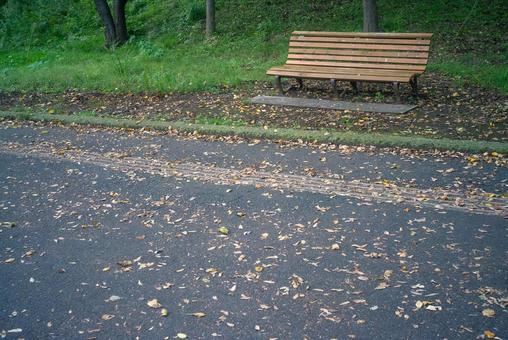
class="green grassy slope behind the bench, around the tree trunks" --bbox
[0,0,508,93]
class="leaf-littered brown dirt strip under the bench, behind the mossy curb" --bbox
[0,73,508,141]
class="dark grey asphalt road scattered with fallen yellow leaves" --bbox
[0,122,508,339]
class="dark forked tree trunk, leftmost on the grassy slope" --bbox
[94,0,129,48]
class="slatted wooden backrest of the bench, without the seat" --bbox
[286,31,432,74]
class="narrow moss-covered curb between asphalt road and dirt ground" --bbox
[0,111,508,154]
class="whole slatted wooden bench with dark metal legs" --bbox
[266,31,432,97]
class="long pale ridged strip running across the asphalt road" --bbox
[0,142,508,218]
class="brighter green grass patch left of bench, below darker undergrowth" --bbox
[0,38,282,92]
